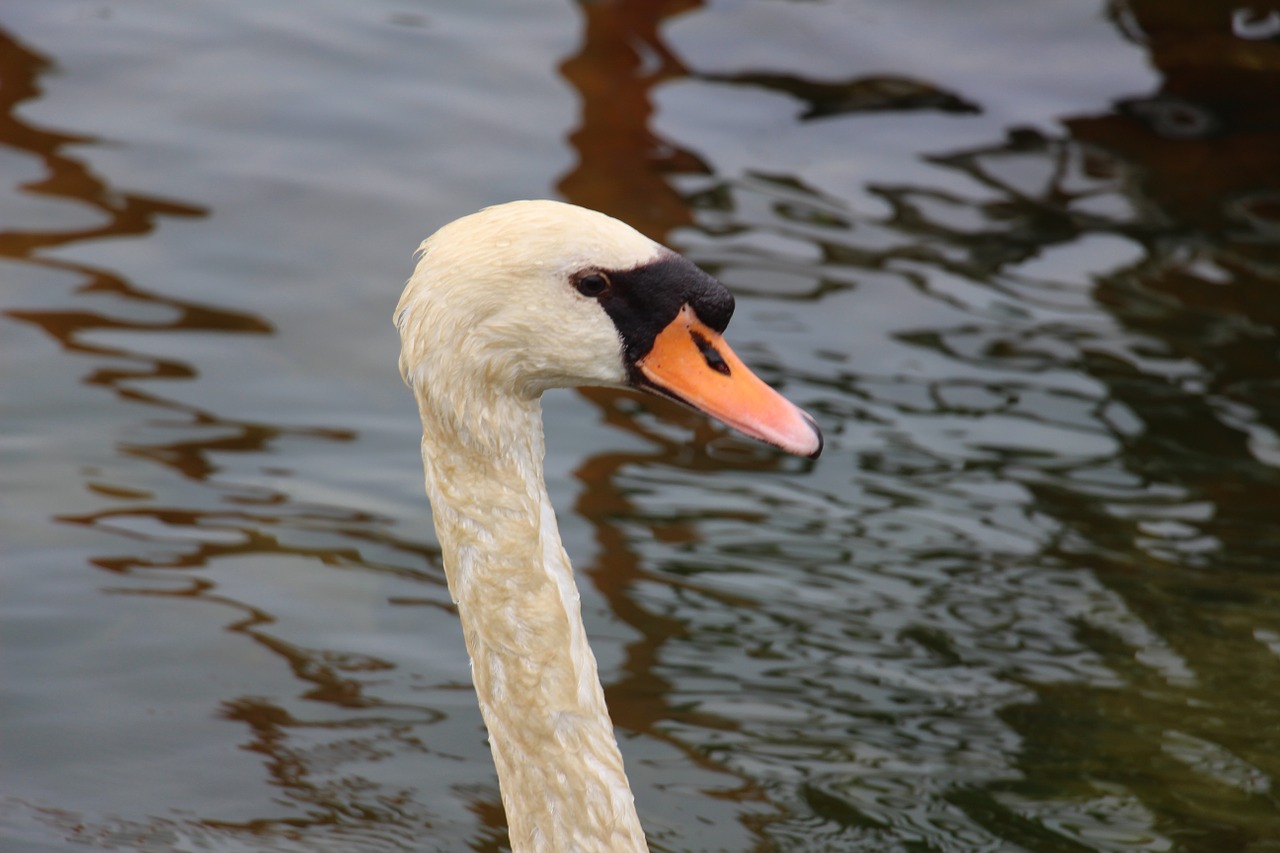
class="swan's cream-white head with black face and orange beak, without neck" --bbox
[396,201,822,457]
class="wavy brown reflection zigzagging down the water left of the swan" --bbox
[0,21,443,849]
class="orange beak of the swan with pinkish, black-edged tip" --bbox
[635,305,822,459]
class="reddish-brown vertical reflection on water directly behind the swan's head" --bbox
[557,0,777,845]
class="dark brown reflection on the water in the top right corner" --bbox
[1095,0,1280,258]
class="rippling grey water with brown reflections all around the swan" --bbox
[0,0,1280,852]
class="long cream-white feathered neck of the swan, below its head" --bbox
[419,396,648,853]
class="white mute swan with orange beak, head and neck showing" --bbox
[396,195,822,853]
